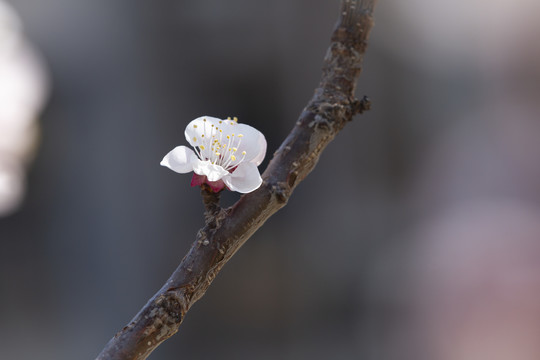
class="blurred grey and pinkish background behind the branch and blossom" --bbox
[0,0,540,360]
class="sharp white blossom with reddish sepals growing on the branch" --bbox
[160,116,266,193]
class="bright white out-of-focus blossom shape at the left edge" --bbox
[0,0,48,216]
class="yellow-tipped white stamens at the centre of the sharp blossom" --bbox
[193,117,246,171]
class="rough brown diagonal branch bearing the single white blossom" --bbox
[97,0,376,360]
